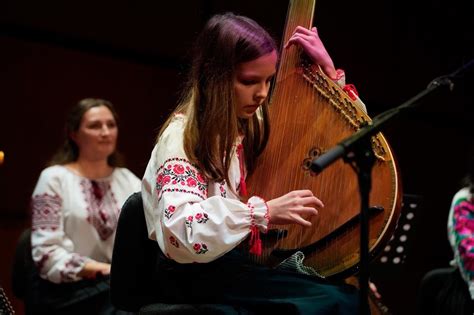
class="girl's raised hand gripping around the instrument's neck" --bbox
[285,26,337,80]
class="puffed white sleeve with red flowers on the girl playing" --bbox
[142,117,269,263]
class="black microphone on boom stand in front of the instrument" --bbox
[311,59,474,315]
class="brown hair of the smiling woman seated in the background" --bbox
[48,98,124,167]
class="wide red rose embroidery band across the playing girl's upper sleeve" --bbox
[155,158,207,199]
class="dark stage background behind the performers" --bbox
[0,0,474,314]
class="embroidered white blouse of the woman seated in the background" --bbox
[31,165,140,283]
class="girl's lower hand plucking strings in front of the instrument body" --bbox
[267,190,324,227]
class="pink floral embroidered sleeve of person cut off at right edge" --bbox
[451,198,474,296]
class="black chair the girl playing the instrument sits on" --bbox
[110,192,239,315]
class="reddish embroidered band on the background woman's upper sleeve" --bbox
[31,193,62,231]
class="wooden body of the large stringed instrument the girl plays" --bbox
[247,0,401,277]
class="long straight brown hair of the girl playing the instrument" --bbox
[160,13,277,183]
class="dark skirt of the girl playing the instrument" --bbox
[154,249,359,315]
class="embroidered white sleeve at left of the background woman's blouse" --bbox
[31,170,88,283]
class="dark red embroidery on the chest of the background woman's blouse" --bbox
[81,179,120,240]
